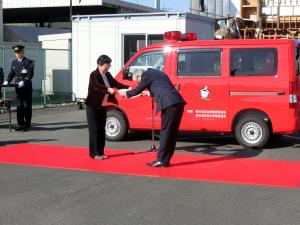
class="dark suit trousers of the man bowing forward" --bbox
[157,103,185,164]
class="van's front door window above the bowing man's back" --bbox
[129,51,165,73]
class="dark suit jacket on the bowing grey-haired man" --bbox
[126,69,186,112]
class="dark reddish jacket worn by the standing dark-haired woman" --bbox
[85,69,129,109]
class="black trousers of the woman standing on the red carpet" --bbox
[86,105,106,157]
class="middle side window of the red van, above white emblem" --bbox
[177,49,221,76]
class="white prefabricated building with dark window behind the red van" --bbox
[72,12,215,98]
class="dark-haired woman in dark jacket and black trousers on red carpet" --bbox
[86,55,129,159]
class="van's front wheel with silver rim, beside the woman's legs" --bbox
[105,109,128,141]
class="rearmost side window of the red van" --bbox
[230,48,277,76]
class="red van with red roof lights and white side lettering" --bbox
[106,31,300,148]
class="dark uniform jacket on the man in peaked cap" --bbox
[7,57,34,94]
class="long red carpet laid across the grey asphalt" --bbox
[0,144,300,188]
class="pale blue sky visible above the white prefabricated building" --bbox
[123,0,190,12]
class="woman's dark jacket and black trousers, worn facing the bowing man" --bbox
[85,69,129,157]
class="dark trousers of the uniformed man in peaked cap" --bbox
[16,89,32,128]
